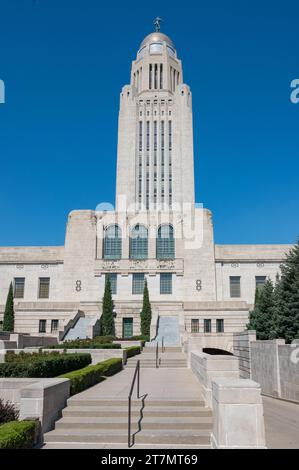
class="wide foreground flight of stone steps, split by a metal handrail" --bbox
[44,397,212,449]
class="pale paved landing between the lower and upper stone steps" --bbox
[71,368,202,400]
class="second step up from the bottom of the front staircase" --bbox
[44,429,211,445]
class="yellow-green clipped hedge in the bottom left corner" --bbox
[0,421,38,449]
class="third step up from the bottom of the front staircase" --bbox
[55,416,212,431]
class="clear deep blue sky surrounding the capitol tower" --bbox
[0,0,299,246]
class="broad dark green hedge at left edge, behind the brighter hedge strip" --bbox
[0,354,91,377]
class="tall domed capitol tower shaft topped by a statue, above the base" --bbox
[116,18,194,211]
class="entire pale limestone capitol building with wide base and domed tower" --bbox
[0,26,291,349]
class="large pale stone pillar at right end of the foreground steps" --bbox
[211,377,266,449]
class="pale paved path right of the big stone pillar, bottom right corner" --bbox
[263,396,299,449]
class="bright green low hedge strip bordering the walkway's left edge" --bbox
[59,358,122,395]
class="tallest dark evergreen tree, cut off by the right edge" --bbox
[275,239,299,343]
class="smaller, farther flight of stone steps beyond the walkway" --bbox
[126,344,187,368]
